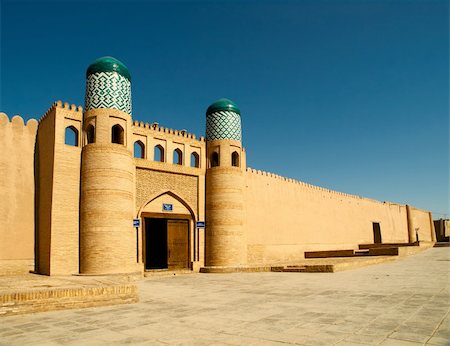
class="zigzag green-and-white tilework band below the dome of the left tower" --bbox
[85,72,131,114]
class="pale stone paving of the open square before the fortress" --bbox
[0,248,450,346]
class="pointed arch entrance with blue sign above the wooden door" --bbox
[138,191,195,270]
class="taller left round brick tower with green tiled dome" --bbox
[80,57,139,274]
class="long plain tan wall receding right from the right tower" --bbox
[245,169,414,264]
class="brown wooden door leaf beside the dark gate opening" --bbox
[167,220,189,269]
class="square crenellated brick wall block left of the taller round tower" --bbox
[36,101,82,275]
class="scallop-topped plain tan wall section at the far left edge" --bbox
[0,113,37,274]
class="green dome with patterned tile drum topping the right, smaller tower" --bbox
[206,98,242,141]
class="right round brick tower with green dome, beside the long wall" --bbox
[205,98,247,267]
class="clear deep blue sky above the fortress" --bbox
[0,0,450,218]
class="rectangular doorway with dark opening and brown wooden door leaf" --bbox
[145,218,189,269]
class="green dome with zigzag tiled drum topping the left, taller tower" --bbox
[85,56,131,114]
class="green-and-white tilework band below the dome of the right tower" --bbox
[206,111,241,141]
